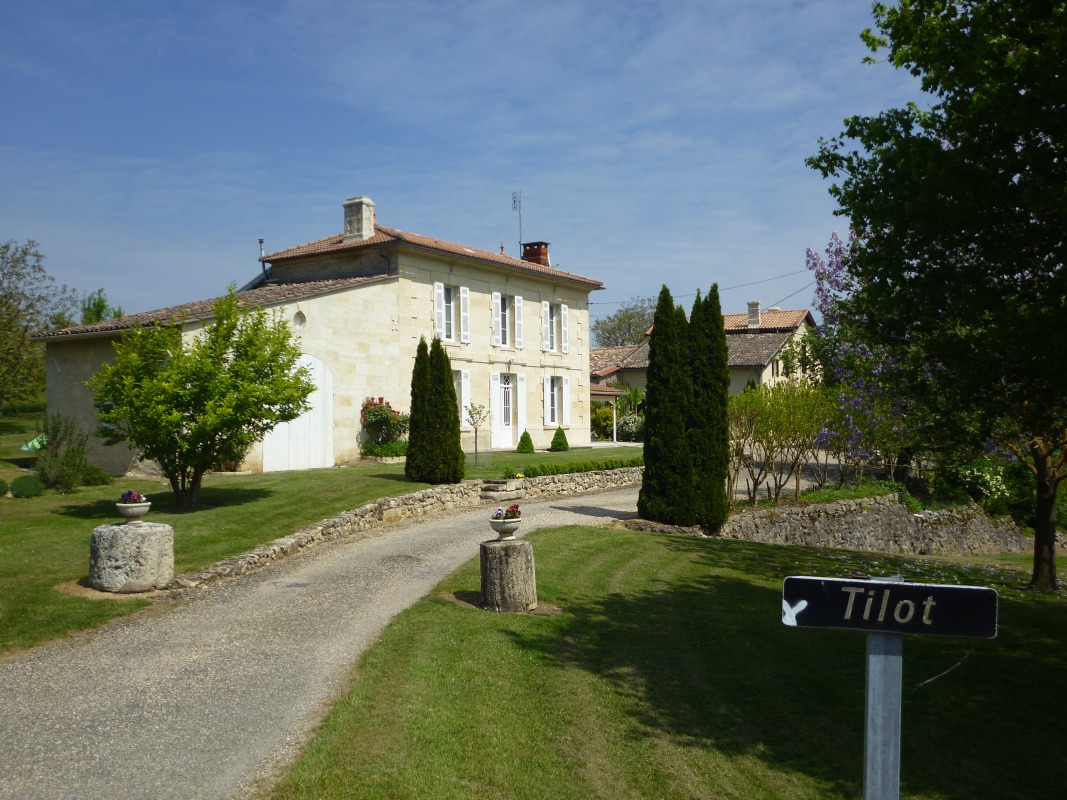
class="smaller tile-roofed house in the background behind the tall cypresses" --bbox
[589,300,815,395]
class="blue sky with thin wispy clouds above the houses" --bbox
[0,0,921,326]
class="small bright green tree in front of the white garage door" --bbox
[89,286,315,507]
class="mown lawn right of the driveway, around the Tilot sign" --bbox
[265,528,1067,800]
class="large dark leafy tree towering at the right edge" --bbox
[809,0,1067,591]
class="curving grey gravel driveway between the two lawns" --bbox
[0,486,637,800]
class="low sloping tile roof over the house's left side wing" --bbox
[34,275,382,341]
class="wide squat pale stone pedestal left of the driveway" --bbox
[89,523,174,592]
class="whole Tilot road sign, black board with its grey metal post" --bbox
[782,575,997,800]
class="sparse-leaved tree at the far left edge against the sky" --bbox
[0,240,75,412]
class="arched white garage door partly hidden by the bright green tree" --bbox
[264,355,334,473]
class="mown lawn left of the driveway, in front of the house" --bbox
[0,414,639,653]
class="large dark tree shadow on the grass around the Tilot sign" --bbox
[505,538,1067,800]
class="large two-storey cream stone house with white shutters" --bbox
[39,197,602,475]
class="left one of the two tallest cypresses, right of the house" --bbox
[637,286,697,525]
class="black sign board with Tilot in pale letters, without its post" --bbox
[782,577,997,639]
